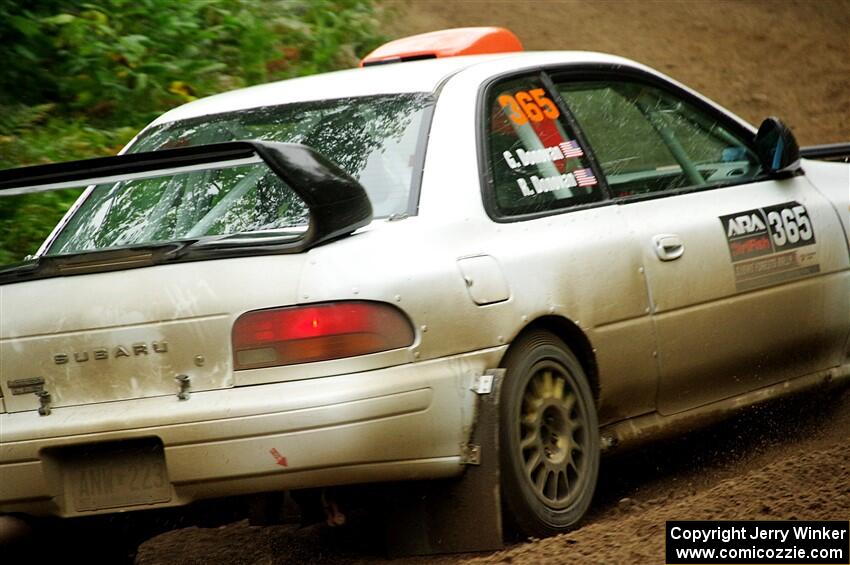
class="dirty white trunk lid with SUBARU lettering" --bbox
[0,254,304,412]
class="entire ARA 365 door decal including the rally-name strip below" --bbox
[720,201,820,290]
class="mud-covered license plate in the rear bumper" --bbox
[63,445,171,511]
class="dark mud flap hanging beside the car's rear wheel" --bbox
[385,369,504,557]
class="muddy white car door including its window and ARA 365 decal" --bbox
[555,73,850,414]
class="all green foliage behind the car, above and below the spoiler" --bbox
[0,0,382,264]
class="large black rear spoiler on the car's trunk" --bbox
[0,141,372,254]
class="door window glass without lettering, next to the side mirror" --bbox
[558,80,761,197]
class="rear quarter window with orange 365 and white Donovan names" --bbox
[485,77,603,216]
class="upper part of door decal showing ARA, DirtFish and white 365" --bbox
[720,201,815,262]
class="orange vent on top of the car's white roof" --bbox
[360,27,522,67]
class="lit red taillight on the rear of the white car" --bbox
[233,301,413,370]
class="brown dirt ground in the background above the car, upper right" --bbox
[384,0,850,145]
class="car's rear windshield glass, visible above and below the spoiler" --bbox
[47,94,433,255]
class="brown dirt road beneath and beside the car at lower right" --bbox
[471,395,850,564]
